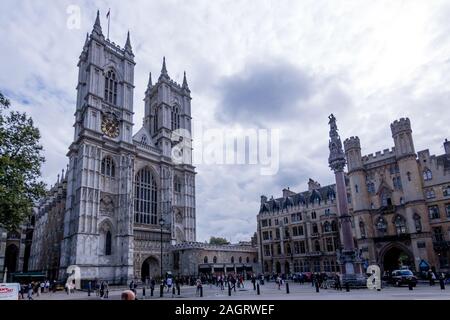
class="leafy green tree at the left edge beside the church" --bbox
[0,92,45,230]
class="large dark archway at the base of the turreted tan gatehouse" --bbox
[380,244,415,272]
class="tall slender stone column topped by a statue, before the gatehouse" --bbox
[328,114,366,286]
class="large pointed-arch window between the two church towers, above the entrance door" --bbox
[134,167,158,225]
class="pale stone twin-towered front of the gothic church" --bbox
[60,12,195,283]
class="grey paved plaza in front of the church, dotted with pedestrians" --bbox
[26,281,450,300]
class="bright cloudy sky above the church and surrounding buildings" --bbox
[0,0,450,242]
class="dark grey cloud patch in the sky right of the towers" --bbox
[216,62,314,122]
